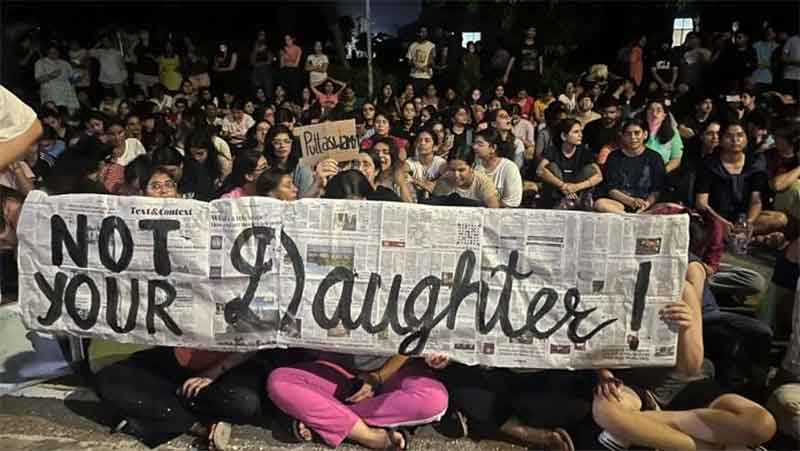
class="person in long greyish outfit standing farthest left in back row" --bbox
[34,43,80,113]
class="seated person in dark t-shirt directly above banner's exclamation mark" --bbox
[594,119,667,213]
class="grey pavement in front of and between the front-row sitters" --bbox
[0,383,525,451]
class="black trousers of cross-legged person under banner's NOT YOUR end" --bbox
[95,347,268,447]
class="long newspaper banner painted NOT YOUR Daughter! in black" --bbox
[19,192,689,368]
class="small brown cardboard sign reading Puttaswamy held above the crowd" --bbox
[294,119,359,166]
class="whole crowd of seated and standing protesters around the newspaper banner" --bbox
[0,19,800,450]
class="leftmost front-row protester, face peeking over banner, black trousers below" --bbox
[94,168,267,449]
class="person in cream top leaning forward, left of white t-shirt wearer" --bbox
[433,146,501,208]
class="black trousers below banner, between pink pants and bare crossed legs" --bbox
[443,364,596,437]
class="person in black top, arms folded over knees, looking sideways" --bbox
[537,119,603,211]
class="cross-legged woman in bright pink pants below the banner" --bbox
[267,353,447,449]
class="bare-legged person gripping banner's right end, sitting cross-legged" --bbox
[592,262,776,450]
